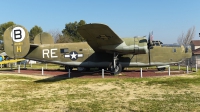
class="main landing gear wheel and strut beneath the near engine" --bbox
[109,52,122,75]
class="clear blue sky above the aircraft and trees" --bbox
[0,0,200,43]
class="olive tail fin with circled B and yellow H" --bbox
[3,25,30,59]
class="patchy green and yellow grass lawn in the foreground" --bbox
[0,68,200,112]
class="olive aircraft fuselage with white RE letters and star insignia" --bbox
[25,42,189,67]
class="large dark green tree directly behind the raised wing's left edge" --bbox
[62,20,86,42]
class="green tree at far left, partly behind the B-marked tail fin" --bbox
[0,21,15,40]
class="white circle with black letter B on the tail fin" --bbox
[10,27,25,42]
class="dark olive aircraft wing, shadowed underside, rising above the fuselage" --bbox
[78,23,123,52]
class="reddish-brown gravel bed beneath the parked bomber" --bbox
[0,70,184,78]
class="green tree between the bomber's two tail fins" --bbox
[29,25,43,41]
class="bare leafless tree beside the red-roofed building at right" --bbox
[177,26,195,46]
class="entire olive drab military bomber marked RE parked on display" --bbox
[3,23,191,74]
